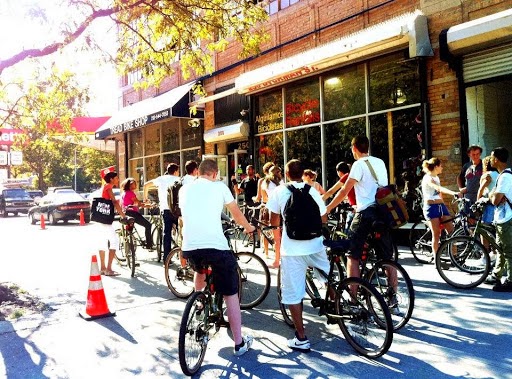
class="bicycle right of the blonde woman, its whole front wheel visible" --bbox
[435,202,494,289]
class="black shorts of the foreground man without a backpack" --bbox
[183,249,238,296]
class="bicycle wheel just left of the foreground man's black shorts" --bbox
[164,247,194,299]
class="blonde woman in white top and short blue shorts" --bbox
[421,158,462,254]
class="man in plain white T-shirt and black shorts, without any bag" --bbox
[179,159,254,356]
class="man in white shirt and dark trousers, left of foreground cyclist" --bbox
[144,163,180,262]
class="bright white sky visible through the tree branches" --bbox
[0,0,119,117]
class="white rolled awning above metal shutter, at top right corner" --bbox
[446,9,512,55]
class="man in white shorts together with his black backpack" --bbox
[267,159,329,352]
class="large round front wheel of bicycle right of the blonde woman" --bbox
[436,236,491,288]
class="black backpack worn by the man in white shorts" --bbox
[283,184,322,241]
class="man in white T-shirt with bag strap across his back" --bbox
[327,136,392,280]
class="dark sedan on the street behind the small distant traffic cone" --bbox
[28,191,91,225]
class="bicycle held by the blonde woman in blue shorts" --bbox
[409,197,472,264]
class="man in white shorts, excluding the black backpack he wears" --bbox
[267,159,329,352]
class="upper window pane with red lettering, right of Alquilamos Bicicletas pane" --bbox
[285,78,320,128]
